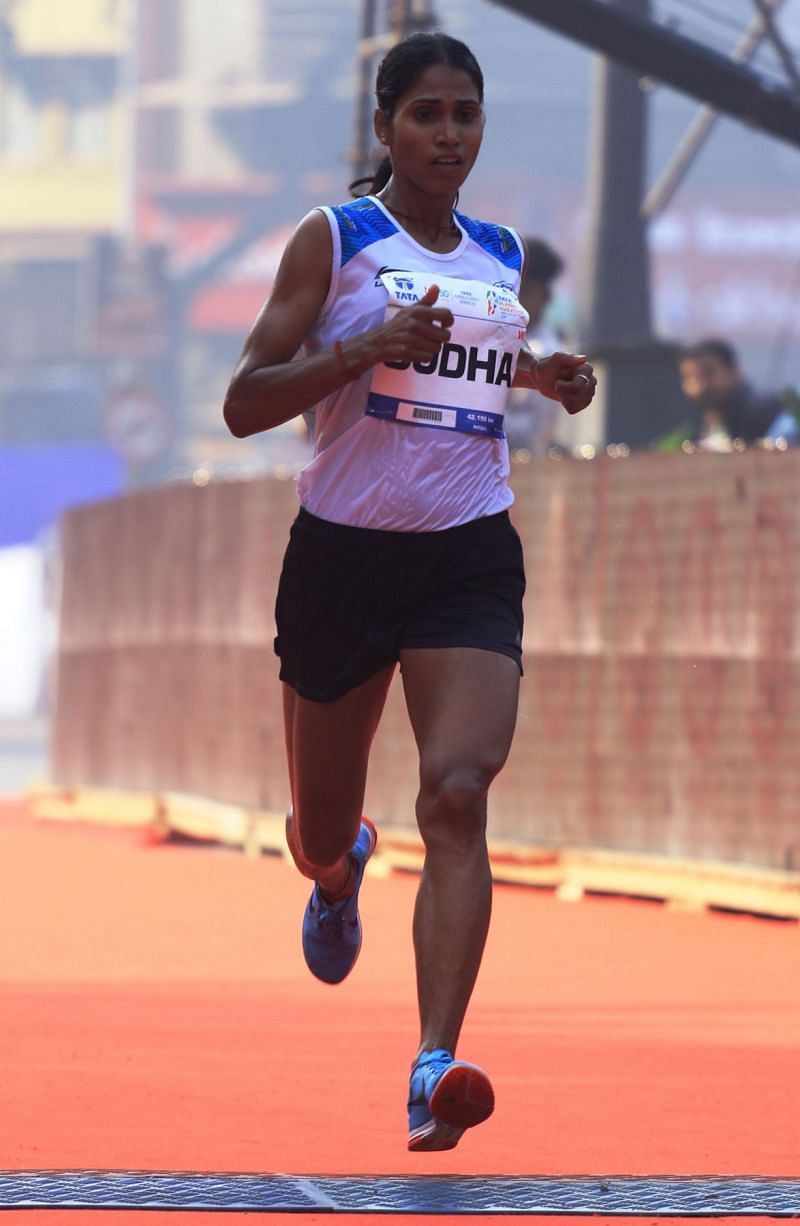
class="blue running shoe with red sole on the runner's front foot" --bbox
[408,1047,495,1150]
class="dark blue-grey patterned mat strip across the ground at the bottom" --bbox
[0,1171,800,1217]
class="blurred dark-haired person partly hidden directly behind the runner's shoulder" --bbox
[506,238,565,455]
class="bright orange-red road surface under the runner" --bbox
[0,802,800,1226]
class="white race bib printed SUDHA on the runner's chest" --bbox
[366,272,528,439]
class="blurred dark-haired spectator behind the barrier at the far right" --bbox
[680,338,800,451]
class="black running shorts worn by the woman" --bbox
[274,509,526,702]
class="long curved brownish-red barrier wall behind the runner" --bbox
[53,450,800,868]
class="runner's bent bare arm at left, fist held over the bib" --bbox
[223,210,452,439]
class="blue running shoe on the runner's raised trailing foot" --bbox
[303,818,377,983]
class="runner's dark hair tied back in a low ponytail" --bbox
[349,31,484,195]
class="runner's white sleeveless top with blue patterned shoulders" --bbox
[292,196,522,532]
